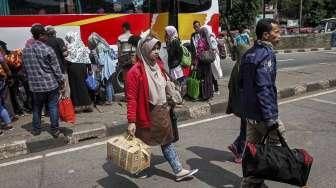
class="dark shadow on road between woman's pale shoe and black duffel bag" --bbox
[187,146,241,187]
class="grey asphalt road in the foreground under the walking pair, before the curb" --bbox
[0,90,336,188]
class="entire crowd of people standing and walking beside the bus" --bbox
[0,16,292,187]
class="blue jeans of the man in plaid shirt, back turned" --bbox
[32,89,59,130]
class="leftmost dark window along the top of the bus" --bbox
[1,0,76,15]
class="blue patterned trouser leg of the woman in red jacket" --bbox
[161,143,182,174]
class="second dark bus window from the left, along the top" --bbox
[79,0,143,14]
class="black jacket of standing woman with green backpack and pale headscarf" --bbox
[167,38,183,69]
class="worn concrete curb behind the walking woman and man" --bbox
[0,78,336,160]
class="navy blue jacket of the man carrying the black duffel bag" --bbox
[239,42,278,121]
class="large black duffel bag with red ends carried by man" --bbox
[242,130,313,186]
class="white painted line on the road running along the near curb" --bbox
[0,89,336,168]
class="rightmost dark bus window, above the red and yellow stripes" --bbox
[178,0,211,13]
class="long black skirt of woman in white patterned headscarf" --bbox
[68,63,92,111]
